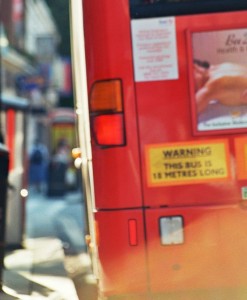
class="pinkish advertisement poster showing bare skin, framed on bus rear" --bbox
[191,28,247,132]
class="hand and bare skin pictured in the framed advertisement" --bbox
[194,61,247,113]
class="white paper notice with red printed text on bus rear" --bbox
[131,17,178,82]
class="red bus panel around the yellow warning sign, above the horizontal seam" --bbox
[136,12,247,206]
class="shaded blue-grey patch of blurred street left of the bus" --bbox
[26,190,85,254]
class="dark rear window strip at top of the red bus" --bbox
[129,0,247,19]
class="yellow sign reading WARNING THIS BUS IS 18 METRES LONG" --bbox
[146,139,230,186]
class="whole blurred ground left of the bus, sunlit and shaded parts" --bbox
[0,190,98,300]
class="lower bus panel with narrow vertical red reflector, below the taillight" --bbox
[96,210,147,295]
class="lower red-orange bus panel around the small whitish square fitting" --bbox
[146,206,247,292]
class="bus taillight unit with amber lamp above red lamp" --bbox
[89,79,126,147]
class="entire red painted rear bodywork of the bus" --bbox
[83,0,247,300]
